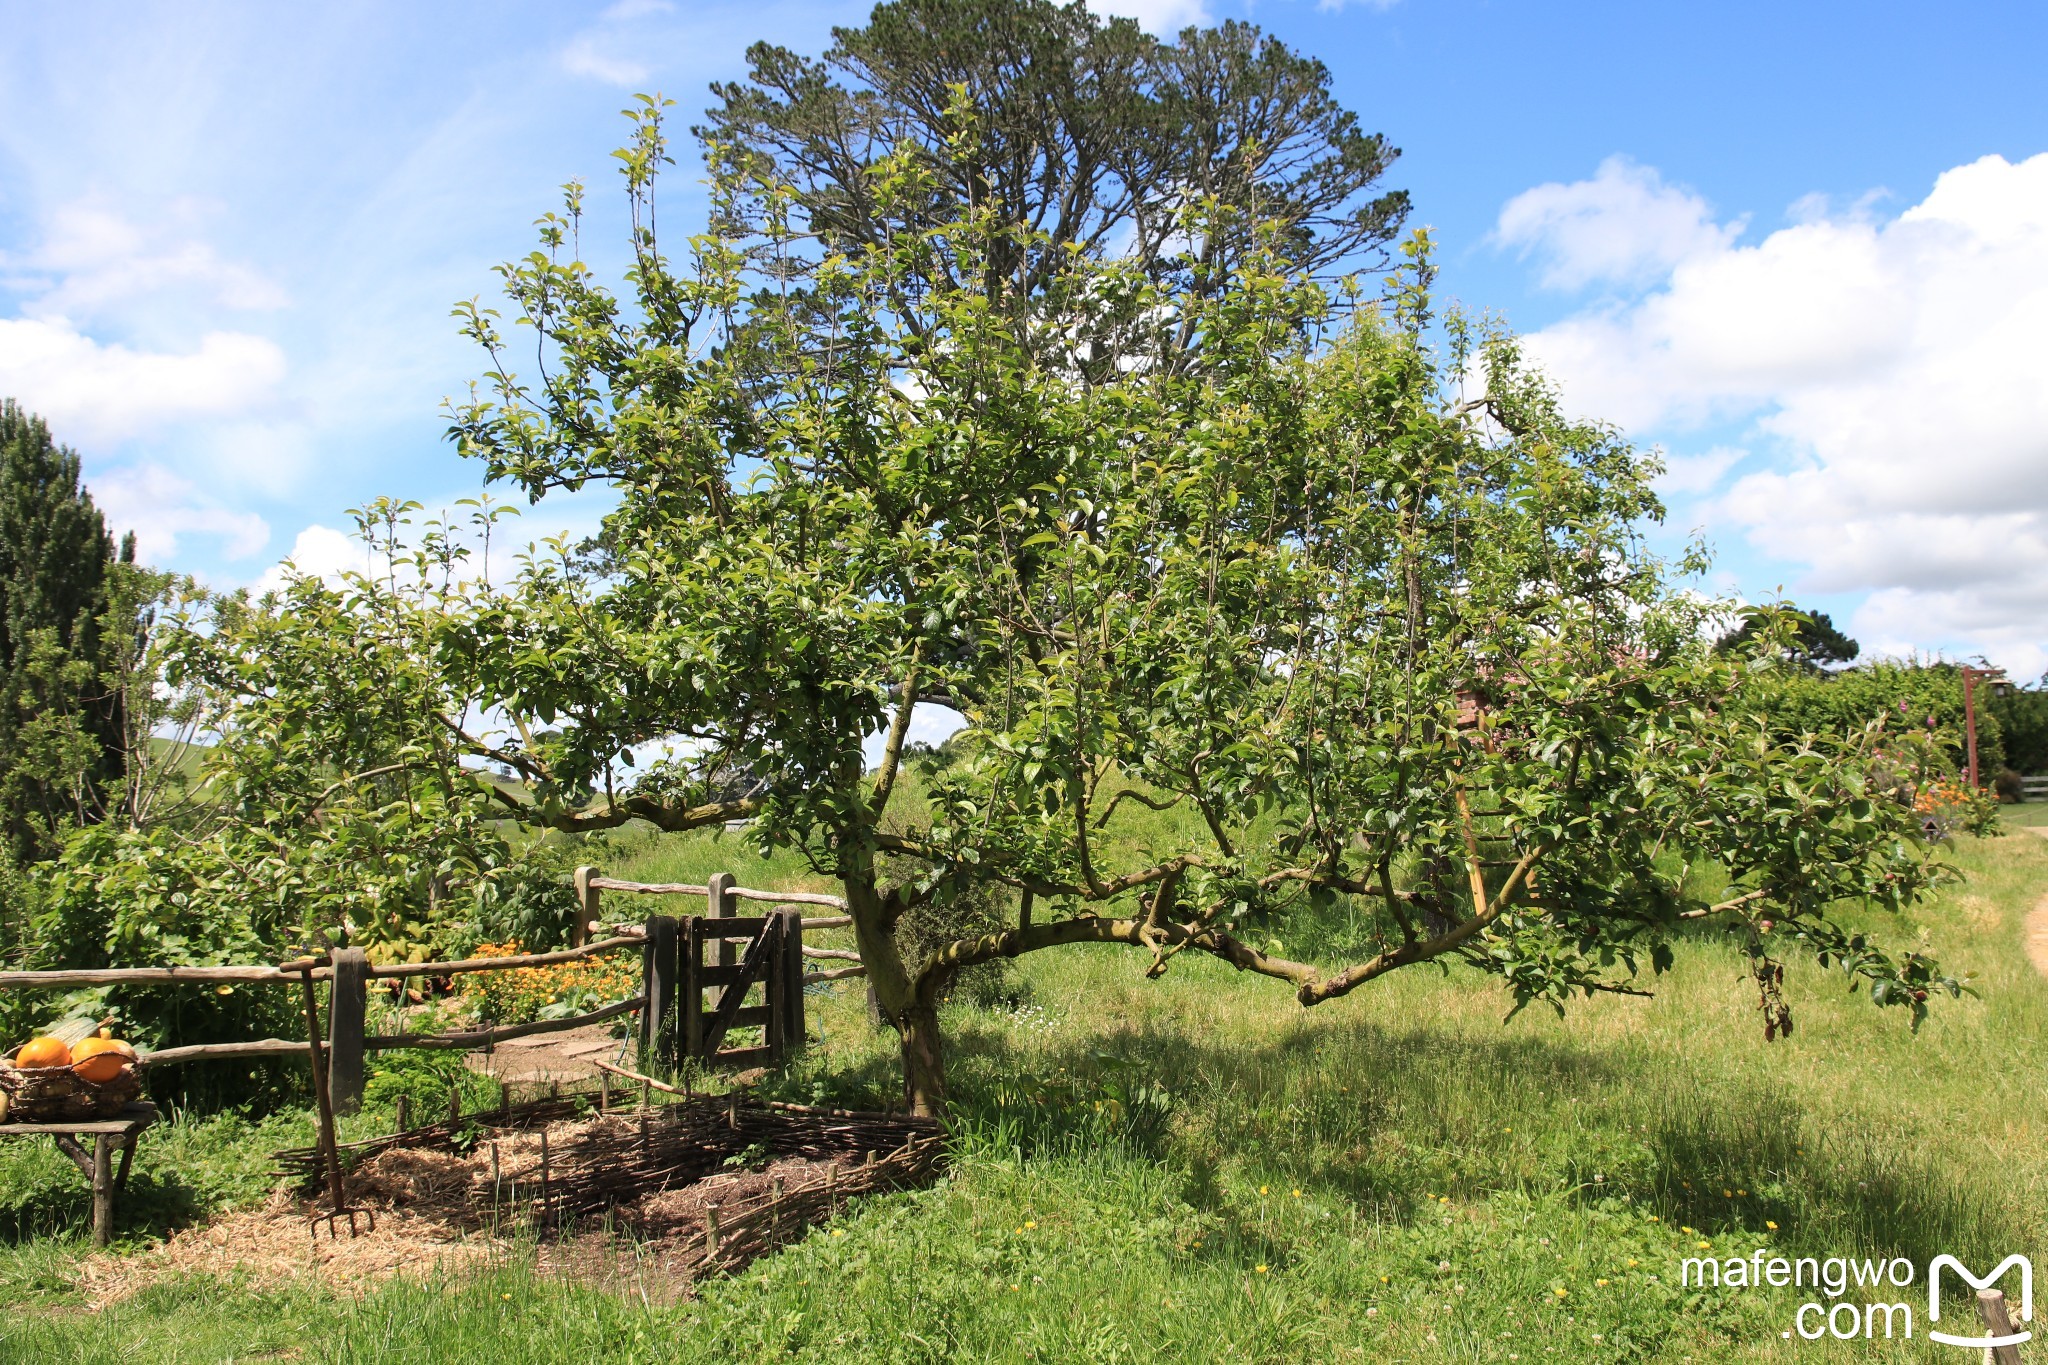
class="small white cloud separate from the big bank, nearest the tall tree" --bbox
[1493,156,1743,289]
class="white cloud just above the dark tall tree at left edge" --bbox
[0,317,285,444]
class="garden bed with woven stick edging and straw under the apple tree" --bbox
[82,1095,944,1306]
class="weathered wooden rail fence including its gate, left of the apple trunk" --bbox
[0,868,866,1109]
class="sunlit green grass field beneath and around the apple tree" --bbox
[0,806,2048,1365]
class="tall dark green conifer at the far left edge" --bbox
[0,399,135,862]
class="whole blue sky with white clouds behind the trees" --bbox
[12,0,2048,677]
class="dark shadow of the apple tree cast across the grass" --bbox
[929,1002,2025,1263]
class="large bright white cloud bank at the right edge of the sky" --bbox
[1503,153,2048,667]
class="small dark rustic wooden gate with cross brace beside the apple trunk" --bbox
[643,874,803,1068]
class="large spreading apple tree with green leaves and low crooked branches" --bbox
[369,101,1954,1111]
